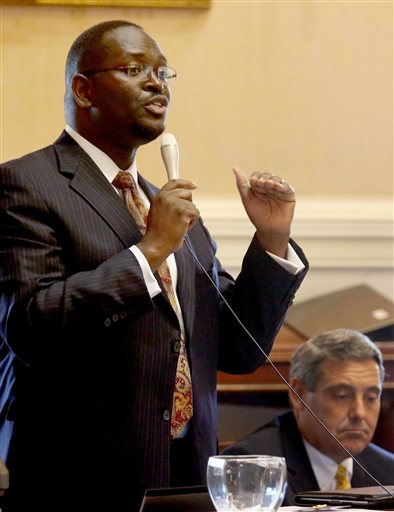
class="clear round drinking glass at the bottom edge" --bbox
[207,455,287,512]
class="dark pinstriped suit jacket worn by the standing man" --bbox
[0,133,307,512]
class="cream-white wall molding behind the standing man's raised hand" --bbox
[195,198,394,298]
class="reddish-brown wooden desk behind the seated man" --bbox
[217,325,394,452]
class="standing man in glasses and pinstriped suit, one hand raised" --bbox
[0,20,308,512]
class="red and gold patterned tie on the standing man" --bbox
[112,171,193,438]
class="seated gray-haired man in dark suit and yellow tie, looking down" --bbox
[223,329,394,506]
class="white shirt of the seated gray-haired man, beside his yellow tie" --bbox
[303,439,353,491]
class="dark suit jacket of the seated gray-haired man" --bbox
[223,411,394,506]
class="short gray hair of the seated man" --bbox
[290,329,384,391]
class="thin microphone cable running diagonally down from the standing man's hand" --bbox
[184,236,394,498]
